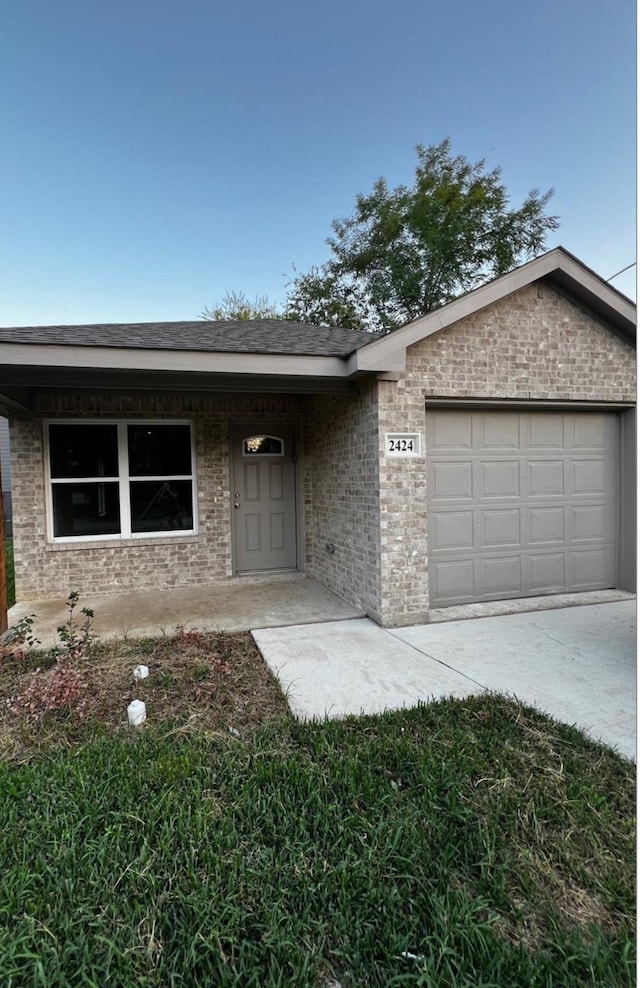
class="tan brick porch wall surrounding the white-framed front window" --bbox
[11,393,311,600]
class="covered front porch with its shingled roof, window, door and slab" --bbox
[0,320,386,620]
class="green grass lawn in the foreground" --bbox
[0,696,635,988]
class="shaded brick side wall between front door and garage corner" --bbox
[308,382,381,616]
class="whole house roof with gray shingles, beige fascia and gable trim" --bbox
[0,247,636,415]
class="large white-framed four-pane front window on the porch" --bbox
[47,422,195,539]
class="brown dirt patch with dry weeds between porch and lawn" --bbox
[0,628,288,759]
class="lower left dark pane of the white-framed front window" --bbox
[52,483,120,538]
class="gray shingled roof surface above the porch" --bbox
[0,319,380,357]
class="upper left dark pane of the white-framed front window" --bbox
[49,424,118,477]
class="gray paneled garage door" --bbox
[426,409,618,607]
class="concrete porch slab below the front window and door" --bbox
[8,577,363,648]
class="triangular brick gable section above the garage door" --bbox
[412,283,636,401]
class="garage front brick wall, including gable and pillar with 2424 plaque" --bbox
[379,283,636,626]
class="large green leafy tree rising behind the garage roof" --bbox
[286,139,559,329]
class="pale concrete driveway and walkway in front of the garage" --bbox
[253,600,636,758]
